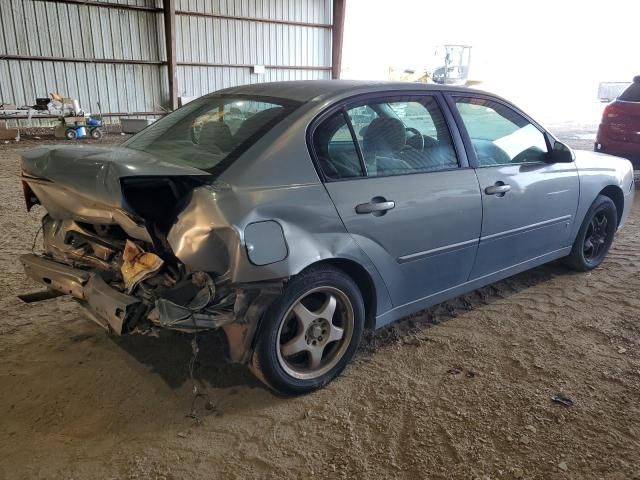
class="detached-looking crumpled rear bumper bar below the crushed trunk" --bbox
[20,254,146,335]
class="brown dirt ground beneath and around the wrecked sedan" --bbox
[0,134,640,479]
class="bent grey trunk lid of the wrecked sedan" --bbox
[22,142,211,242]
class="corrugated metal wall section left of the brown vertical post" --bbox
[0,0,167,120]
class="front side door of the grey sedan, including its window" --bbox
[453,96,579,279]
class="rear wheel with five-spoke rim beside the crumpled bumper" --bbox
[250,266,365,395]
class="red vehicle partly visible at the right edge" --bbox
[595,75,640,170]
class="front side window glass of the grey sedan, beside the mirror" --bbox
[455,97,548,167]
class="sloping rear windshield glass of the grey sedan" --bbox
[123,94,300,173]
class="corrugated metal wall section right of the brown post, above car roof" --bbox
[176,0,331,97]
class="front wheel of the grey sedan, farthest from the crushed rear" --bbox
[564,195,618,272]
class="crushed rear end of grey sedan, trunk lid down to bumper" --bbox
[22,147,248,340]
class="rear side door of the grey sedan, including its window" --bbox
[313,95,482,306]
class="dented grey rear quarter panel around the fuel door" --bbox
[167,182,391,312]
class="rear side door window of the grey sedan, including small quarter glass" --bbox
[313,96,458,180]
